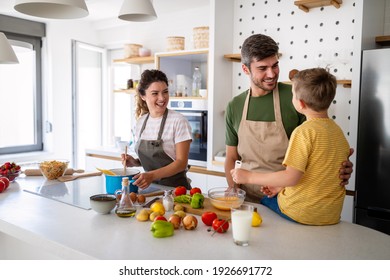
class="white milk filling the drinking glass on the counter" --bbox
[231,210,253,243]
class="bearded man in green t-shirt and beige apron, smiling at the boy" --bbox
[225,34,353,203]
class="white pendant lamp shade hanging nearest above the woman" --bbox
[118,0,157,21]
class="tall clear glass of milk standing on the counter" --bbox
[231,204,254,246]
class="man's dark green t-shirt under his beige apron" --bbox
[225,83,306,146]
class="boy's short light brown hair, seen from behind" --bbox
[292,68,337,112]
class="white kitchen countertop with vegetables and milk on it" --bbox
[0,175,390,260]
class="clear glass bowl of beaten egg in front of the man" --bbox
[208,188,246,211]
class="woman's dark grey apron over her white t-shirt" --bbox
[135,109,191,189]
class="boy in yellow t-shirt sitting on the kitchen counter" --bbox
[231,68,349,225]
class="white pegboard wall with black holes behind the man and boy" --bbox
[233,0,356,138]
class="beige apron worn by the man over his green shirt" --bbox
[237,86,288,203]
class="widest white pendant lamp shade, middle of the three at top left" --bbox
[14,0,89,19]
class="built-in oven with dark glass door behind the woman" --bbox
[169,99,207,167]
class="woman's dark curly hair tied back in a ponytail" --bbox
[135,69,168,119]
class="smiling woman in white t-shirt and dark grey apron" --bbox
[122,70,192,189]
